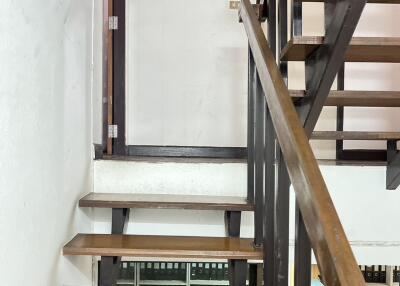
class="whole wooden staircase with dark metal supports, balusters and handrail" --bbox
[63,0,400,286]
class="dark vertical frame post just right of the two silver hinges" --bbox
[113,0,126,155]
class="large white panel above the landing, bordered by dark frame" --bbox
[127,0,247,146]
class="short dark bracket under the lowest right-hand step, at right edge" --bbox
[386,140,400,190]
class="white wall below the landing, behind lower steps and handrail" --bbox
[93,161,400,265]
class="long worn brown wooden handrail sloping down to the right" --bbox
[239,0,365,286]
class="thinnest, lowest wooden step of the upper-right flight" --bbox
[311,131,400,141]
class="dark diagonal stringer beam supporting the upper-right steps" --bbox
[299,0,366,137]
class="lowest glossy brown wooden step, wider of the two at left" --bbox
[63,234,263,260]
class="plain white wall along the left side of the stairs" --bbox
[0,0,93,286]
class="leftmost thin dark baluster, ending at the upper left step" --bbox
[247,46,256,203]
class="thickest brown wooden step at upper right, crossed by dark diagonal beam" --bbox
[282,36,400,63]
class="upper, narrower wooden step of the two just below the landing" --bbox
[79,193,254,211]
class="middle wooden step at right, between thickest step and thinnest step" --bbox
[290,90,400,107]
